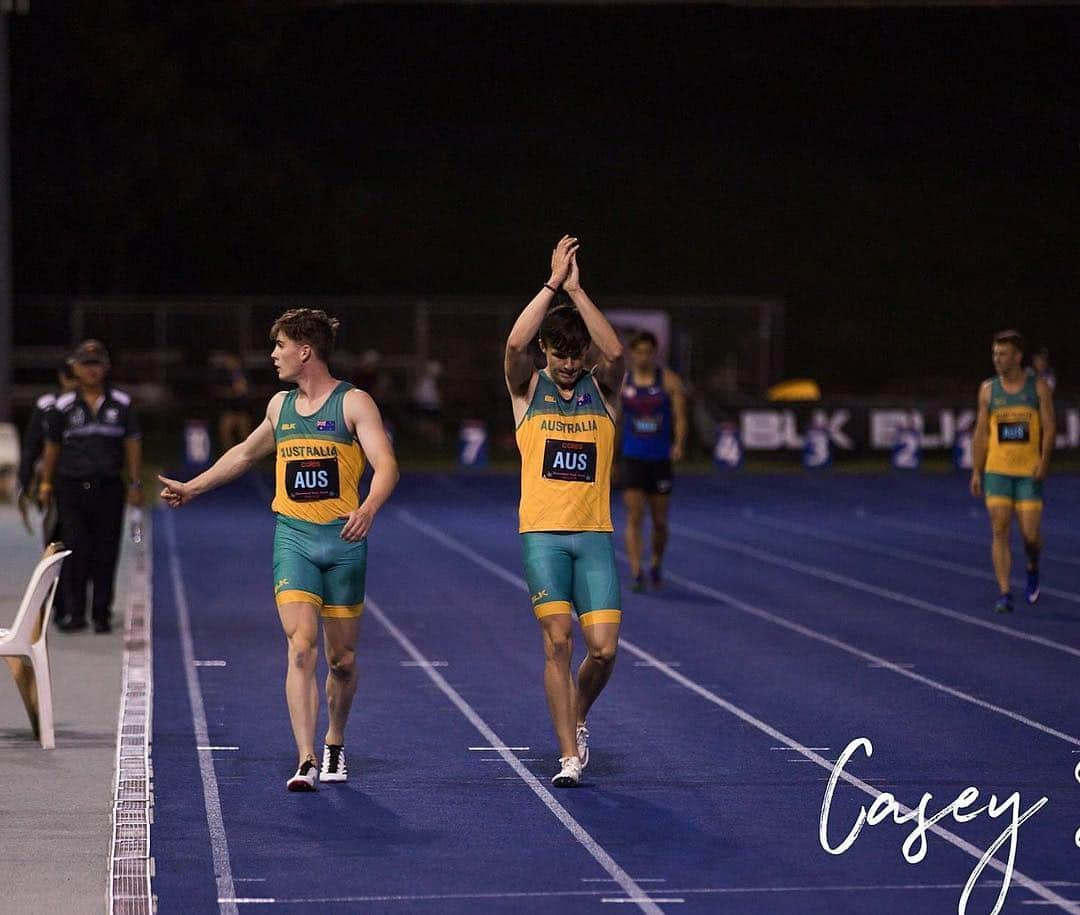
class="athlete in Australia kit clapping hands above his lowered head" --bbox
[504,236,623,788]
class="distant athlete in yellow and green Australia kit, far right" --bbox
[971,331,1056,614]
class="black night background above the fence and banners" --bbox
[11,2,1080,398]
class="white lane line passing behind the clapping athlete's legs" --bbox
[397,509,1080,915]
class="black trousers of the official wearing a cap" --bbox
[56,476,124,622]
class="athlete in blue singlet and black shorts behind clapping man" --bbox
[620,331,687,591]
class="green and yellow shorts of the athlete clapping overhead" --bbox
[522,530,622,625]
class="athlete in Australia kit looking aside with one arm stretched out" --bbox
[159,308,397,791]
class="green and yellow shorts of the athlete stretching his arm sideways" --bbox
[273,514,367,619]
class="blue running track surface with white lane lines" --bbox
[151,473,1080,915]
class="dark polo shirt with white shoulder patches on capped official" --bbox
[45,388,143,480]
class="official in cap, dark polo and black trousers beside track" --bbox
[38,340,143,632]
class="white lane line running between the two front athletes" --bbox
[364,596,663,915]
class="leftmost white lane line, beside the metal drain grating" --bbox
[162,511,237,915]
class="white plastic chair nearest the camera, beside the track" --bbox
[0,550,71,750]
